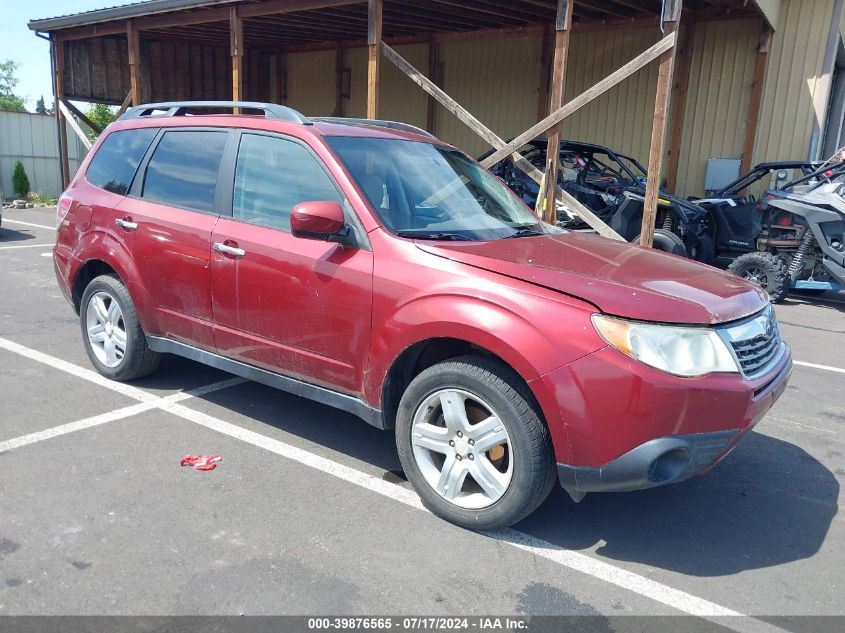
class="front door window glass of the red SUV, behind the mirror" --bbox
[232,134,342,231]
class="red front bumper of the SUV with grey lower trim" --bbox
[546,346,792,494]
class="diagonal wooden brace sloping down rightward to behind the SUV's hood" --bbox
[381,42,622,240]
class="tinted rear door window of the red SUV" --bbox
[141,130,228,211]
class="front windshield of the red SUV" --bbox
[326,136,546,240]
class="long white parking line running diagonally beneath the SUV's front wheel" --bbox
[0,338,786,633]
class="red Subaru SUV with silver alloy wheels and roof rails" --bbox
[54,102,792,529]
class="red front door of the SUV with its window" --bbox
[211,132,373,393]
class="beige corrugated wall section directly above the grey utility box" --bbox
[676,19,761,195]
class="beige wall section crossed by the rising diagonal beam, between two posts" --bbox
[562,29,660,163]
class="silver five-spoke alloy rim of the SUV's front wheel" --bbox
[411,389,513,510]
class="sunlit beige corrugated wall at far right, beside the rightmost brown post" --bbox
[754,0,833,162]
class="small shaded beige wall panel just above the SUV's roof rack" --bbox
[287,50,336,116]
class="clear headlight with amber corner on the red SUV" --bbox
[593,314,739,376]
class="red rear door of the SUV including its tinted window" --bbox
[117,128,233,350]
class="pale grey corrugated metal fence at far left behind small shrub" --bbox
[0,112,85,198]
